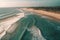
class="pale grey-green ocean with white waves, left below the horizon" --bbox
[0,8,21,19]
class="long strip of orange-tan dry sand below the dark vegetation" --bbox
[22,8,60,21]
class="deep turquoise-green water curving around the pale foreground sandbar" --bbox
[10,15,60,40]
